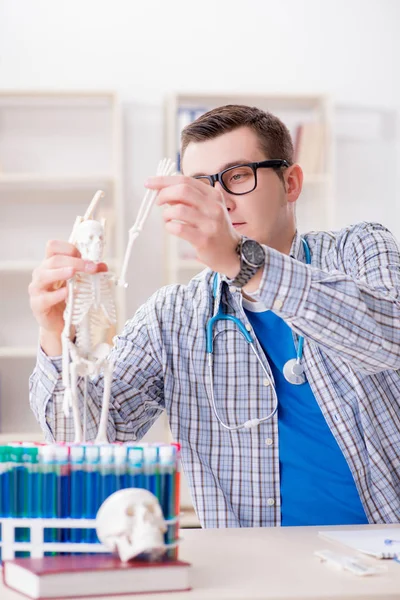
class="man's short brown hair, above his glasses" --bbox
[181,104,293,165]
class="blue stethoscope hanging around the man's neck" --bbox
[206,238,311,431]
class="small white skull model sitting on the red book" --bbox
[96,488,167,562]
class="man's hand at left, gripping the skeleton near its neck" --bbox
[29,240,107,356]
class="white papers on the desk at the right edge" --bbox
[319,528,400,559]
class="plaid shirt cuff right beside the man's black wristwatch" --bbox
[246,246,311,317]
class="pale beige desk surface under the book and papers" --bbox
[0,524,400,600]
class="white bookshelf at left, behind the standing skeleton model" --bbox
[0,90,126,437]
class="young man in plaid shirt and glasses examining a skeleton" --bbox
[30,106,400,527]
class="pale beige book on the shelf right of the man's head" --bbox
[294,121,326,175]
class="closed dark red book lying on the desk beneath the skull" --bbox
[3,554,191,600]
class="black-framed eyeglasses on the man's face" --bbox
[195,158,289,196]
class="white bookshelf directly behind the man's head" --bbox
[165,93,335,284]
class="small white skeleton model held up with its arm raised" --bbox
[62,159,175,444]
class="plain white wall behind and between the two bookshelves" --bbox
[0,0,400,436]
